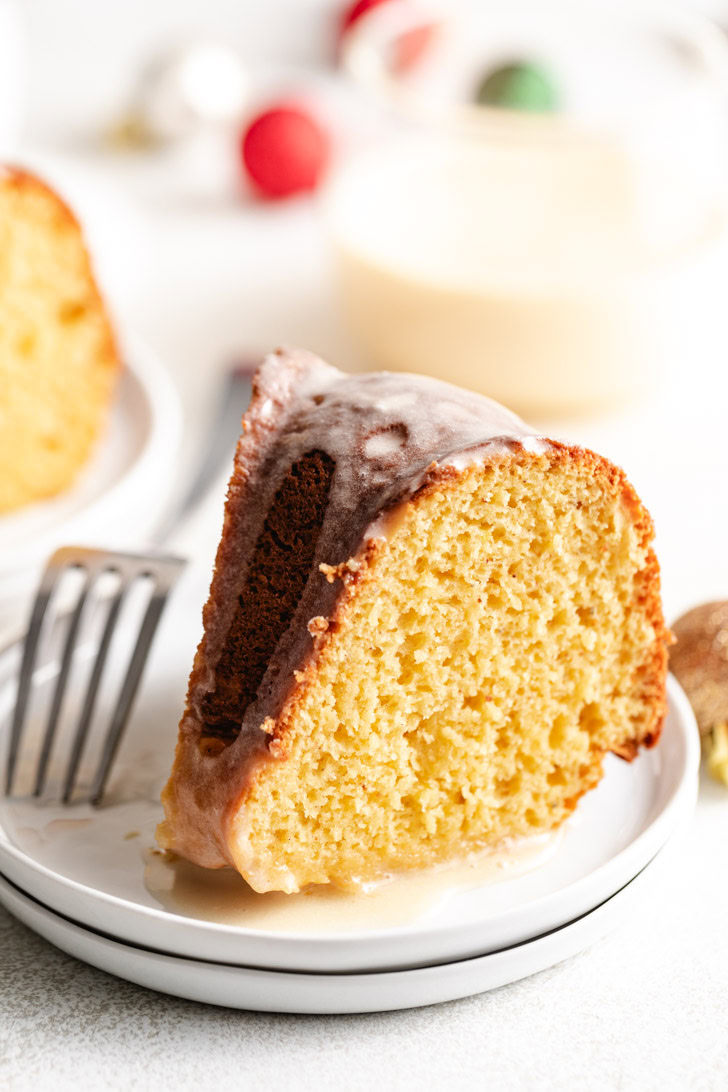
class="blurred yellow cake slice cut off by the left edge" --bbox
[0,167,119,512]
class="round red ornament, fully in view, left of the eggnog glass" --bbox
[240,105,330,198]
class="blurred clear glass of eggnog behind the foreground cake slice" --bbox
[325,0,728,415]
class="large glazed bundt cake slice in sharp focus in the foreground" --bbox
[158,352,667,891]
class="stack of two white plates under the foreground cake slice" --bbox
[0,571,699,1012]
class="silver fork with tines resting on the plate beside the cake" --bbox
[5,367,251,807]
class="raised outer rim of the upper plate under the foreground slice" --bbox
[0,672,700,971]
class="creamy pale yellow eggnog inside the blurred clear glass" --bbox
[330,140,726,414]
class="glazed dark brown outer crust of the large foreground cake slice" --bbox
[159,352,667,868]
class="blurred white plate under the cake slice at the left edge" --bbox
[0,339,181,625]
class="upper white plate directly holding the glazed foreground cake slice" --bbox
[0,554,700,972]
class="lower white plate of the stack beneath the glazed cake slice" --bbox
[0,856,659,1013]
